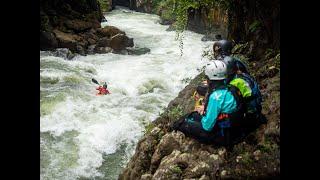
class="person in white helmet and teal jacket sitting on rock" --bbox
[171,60,243,146]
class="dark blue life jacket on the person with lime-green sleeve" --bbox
[235,73,262,113]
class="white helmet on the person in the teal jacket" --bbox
[205,60,227,80]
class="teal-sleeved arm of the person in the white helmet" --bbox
[201,91,223,131]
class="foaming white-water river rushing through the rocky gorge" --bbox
[40,9,212,180]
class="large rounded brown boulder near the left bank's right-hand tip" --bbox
[110,34,134,51]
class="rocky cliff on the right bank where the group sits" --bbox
[114,0,280,180]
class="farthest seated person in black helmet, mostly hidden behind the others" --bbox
[213,40,250,74]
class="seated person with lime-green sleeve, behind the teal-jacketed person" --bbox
[226,60,267,132]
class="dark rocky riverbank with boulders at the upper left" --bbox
[40,0,141,55]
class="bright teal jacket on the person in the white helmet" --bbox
[201,89,237,131]
